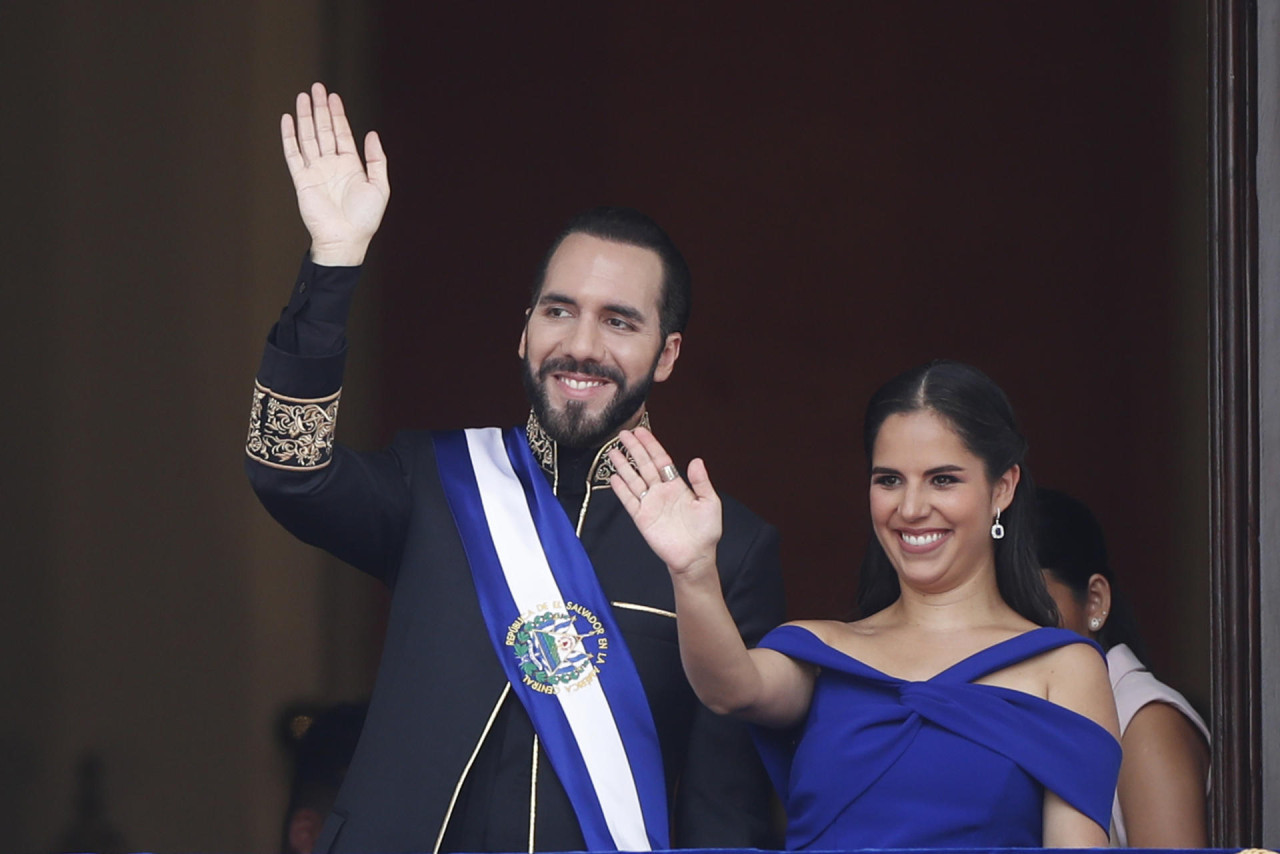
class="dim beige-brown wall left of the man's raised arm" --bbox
[0,0,372,851]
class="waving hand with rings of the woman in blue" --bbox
[609,428,723,575]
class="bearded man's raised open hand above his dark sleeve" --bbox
[280,83,392,266]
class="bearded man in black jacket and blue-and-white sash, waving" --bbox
[246,83,783,851]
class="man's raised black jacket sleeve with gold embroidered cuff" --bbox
[244,261,413,584]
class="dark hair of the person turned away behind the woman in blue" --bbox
[1036,489,1147,661]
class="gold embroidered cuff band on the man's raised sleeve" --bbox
[244,382,342,469]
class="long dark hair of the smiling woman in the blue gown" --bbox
[858,360,1057,626]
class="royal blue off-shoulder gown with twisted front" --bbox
[753,626,1120,850]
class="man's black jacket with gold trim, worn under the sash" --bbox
[246,264,783,851]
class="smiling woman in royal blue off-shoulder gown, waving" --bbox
[611,361,1120,850]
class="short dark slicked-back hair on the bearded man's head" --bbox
[529,206,692,339]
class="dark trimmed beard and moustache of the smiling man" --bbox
[521,353,660,448]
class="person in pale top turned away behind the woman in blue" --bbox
[1037,489,1210,848]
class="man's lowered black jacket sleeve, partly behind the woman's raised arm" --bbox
[672,517,786,849]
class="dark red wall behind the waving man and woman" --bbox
[368,6,1203,686]
